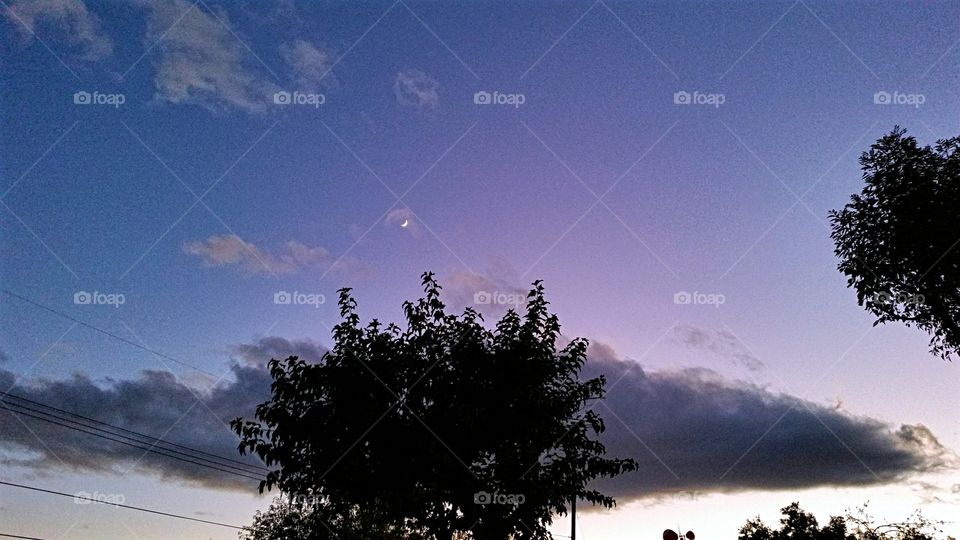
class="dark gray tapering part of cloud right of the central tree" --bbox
[584,346,953,499]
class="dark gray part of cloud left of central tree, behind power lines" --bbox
[0,365,270,490]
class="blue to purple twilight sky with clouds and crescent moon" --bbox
[0,0,960,540]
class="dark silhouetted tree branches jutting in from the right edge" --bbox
[830,127,960,359]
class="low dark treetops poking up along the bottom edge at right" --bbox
[738,502,939,540]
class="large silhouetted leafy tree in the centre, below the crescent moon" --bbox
[232,273,636,540]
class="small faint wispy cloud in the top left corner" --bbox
[6,0,113,61]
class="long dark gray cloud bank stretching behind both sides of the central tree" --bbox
[0,337,954,501]
